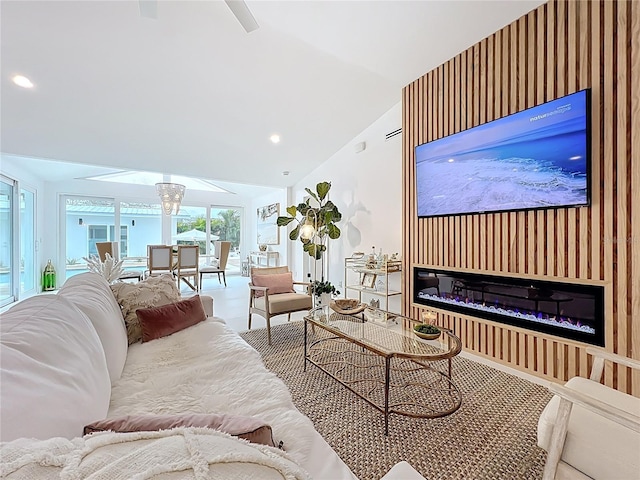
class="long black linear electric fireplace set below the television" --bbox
[413,267,604,347]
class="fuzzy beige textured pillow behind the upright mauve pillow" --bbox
[111,274,180,345]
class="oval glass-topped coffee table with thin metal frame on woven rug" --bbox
[304,307,462,435]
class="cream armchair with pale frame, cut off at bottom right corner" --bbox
[538,348,640,480]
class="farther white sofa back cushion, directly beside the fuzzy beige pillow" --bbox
[58,273,129,383]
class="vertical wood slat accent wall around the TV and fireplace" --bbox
[403,0,640,396]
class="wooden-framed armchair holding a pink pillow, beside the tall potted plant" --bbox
[249,266,313,345]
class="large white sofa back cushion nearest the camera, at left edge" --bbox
[0,295,111,442]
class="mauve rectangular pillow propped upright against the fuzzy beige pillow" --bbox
[136,295,207,342]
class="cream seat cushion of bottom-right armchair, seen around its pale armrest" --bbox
[538,377,640,479]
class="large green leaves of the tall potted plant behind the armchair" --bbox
[277,182,342,262]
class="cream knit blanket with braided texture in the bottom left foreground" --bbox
[0,428,309,480]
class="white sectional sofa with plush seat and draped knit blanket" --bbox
[0,273,355,480]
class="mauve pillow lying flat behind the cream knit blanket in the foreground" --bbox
[83,413,275,447]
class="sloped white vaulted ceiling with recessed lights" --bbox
[0,0,543,187]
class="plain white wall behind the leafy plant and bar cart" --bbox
[289,103,402,308]
